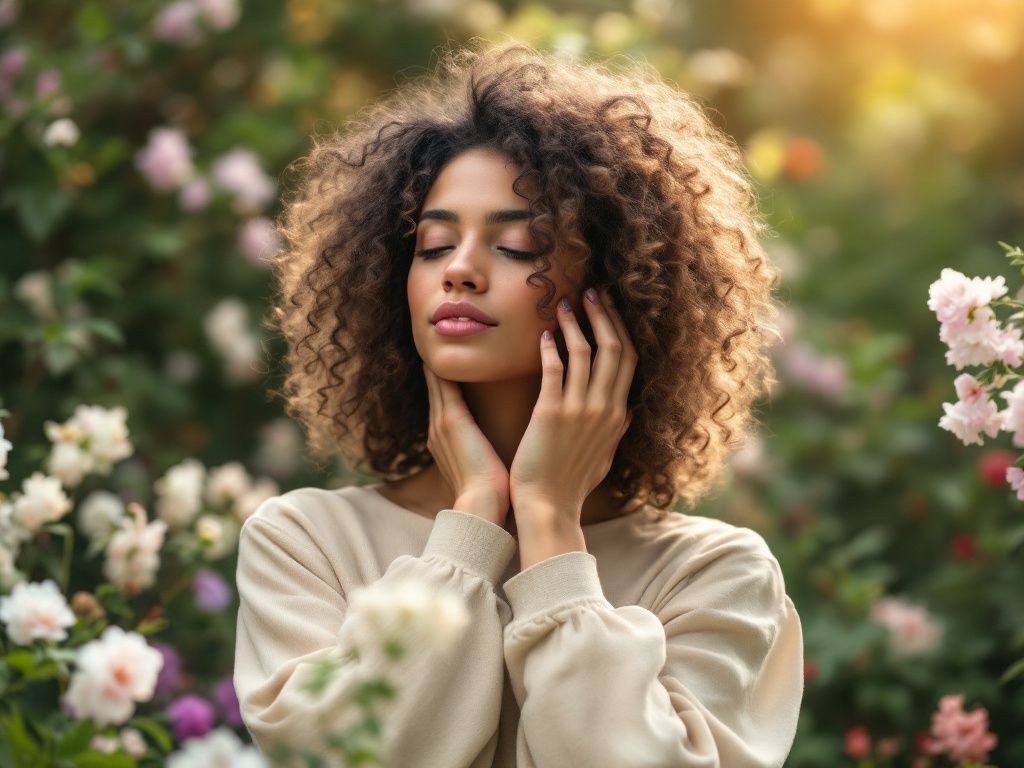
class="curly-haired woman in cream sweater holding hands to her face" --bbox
[234,39,803,768]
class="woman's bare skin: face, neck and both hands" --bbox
[381,147,639,568]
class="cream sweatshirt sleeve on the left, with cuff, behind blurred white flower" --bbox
[233,500,515,768]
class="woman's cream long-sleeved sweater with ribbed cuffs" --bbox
[234,486,803,768]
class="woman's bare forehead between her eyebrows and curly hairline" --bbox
[423,147,531,210]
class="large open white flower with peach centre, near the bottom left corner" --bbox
[66,626,164,727]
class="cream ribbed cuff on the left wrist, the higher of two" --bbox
[423,509,516,585]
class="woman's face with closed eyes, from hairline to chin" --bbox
[407,148,582,382]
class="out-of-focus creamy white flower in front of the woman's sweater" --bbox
[344,580,469,655]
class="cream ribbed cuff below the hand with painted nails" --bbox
[504,552,606,617]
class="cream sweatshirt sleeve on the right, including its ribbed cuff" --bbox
[504,538,804,768]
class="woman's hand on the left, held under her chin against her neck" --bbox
[423,362,509,526]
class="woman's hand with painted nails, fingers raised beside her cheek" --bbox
[509,291,637,528]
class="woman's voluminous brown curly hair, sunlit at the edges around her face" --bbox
[267,41,779,510]
